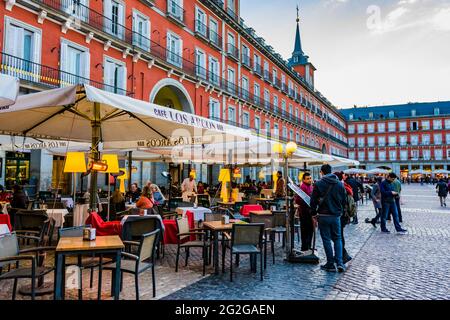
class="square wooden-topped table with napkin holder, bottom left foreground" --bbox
[55,236,125,300]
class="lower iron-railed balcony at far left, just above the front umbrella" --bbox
[0,52,133,96]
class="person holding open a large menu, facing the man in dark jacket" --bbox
[295,172,314,251]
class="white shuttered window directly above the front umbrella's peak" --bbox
[61,39,90,84]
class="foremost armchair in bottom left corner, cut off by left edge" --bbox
[0,232,56,300]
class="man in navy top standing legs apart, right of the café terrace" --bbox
[380,173,407,233]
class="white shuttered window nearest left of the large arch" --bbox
[103,57,127,94]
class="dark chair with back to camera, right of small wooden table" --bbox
[230,223,265,282]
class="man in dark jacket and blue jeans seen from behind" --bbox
[310,164,347,272]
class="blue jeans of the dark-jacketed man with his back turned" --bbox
[318,215,343,266]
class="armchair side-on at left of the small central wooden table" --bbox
[175,218,211,275]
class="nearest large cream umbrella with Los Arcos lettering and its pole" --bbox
[0,85,250,209]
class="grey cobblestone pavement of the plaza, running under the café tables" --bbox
[0,185,450,300]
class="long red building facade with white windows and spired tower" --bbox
[0,0,347,189]
